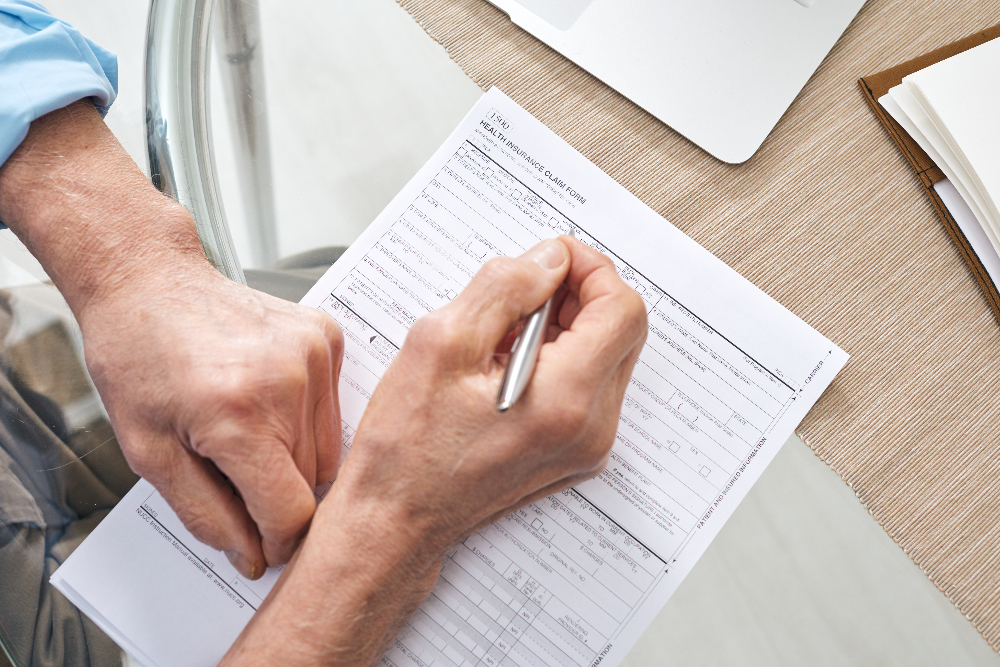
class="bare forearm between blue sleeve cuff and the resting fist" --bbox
[0,100,207,317]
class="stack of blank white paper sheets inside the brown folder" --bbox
[879,39,1000,283]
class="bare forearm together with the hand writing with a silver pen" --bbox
[228,237,646,666]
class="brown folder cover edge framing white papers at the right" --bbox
[858,23,1000,321]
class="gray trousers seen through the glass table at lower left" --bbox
[0,372,137,667]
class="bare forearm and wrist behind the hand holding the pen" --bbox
[222,479,441,667]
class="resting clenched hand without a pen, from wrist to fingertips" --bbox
[80,263,343,578]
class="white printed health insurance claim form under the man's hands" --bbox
[53,89,847,667]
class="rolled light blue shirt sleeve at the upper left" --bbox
[0,0,118,165]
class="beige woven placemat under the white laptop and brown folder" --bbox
[399,0,1000,649]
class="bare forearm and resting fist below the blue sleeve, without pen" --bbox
[0,101,343,578]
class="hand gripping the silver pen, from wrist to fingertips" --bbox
[347,237,646,550]
